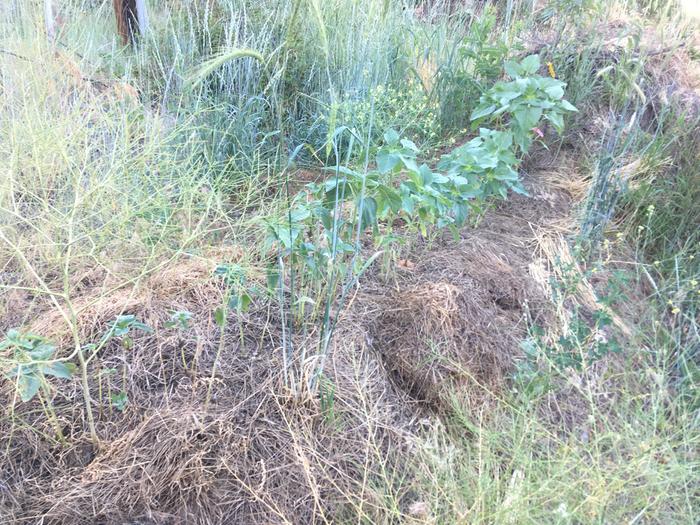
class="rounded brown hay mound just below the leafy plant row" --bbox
[372,170,570,412]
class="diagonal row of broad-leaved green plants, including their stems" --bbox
[266,55,576,390]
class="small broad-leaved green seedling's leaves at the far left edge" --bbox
[0,330,76,401]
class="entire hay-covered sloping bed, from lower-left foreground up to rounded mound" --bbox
[0,154,570,524]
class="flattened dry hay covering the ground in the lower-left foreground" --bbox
[0,249,412,524]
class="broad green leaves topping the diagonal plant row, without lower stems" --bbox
[267,55,575,258]
